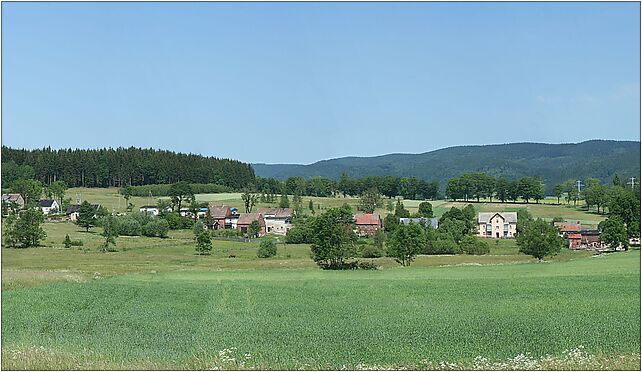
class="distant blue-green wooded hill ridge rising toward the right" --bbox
[252,140,640,191]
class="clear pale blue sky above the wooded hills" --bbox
[2,2,640,164]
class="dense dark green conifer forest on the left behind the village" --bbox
[2,146,254,188]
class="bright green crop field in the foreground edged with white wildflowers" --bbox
[2,251,640,369]
